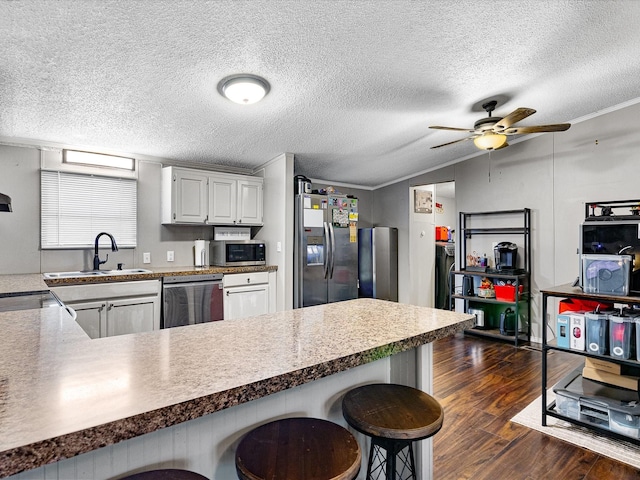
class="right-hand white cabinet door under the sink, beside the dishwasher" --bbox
[106,297,159,337]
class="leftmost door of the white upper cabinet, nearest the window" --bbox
[172,169,207,223]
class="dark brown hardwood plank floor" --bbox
[433,334,640,480]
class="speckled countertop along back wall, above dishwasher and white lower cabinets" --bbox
[42,265,278,286]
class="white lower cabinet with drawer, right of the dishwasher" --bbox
[222,272,275,320]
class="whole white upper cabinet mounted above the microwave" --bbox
[162,167,262,226]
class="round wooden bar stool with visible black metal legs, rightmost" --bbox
[342,383,444,480]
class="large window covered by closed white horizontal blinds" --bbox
[40,170,137,249]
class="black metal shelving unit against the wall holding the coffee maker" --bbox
[449,208,531,347]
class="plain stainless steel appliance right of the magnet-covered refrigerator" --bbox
[358,227,398,302]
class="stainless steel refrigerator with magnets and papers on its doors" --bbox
[293,193,358,308]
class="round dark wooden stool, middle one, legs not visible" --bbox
[236,418,362,480]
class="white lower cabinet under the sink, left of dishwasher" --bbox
[51,280,160,338]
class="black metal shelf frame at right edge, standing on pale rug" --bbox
[541,284,640,445]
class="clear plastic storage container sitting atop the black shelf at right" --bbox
[582,254,632,296]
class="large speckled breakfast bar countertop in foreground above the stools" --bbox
[0,299,473,476]
